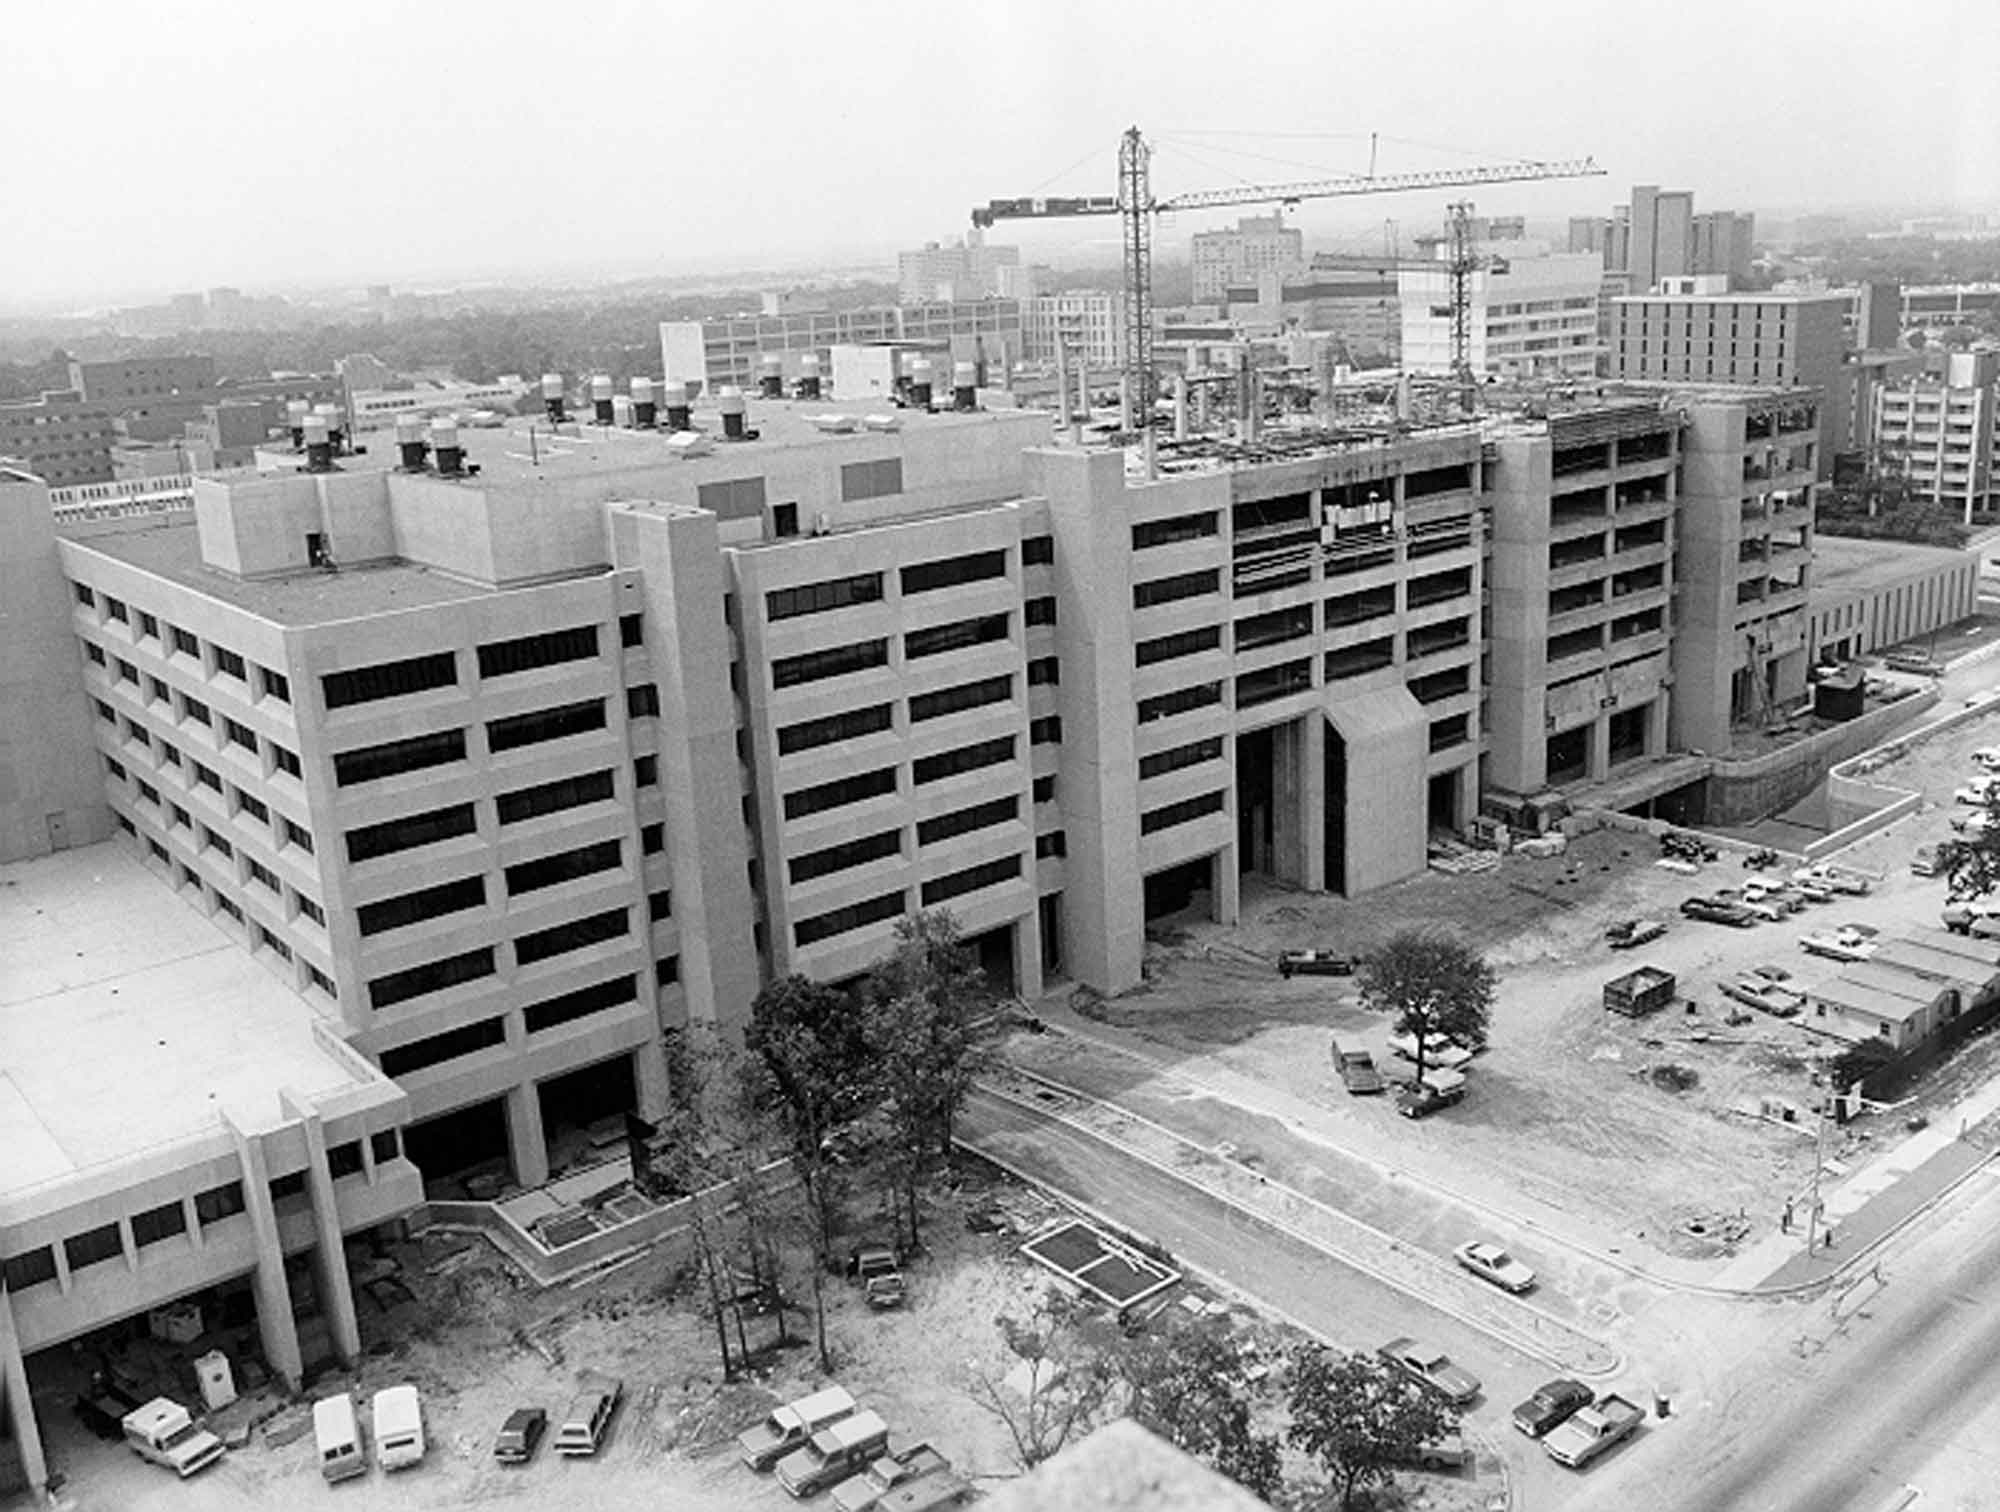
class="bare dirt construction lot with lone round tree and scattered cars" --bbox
[1090,784,2000,1260]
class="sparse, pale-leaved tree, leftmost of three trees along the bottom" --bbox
[966,1290,1120,1470]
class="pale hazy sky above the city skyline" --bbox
[0,0,2000,304]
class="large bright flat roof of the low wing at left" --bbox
[0,842,364,1198]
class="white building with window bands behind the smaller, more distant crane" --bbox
[1396,252,1602,378]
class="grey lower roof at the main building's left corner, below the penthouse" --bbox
[68,516,512,626]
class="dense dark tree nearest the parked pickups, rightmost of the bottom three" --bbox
[1286,1344,1458,1512]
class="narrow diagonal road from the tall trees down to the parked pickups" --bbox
[960,1090,1560,1508]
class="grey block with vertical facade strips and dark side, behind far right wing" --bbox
[1610,280,1852,478]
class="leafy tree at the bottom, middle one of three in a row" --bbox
[1118,1324,1284,1502]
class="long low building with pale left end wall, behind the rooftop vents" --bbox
[660,300,1024,392]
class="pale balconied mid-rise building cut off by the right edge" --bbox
[1874,352,2000,524]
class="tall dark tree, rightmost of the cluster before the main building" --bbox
[862,910,982,1246]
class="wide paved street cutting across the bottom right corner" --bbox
[1566,1178,2000,1512]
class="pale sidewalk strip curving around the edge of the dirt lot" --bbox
[1026,996,2000,1296]
